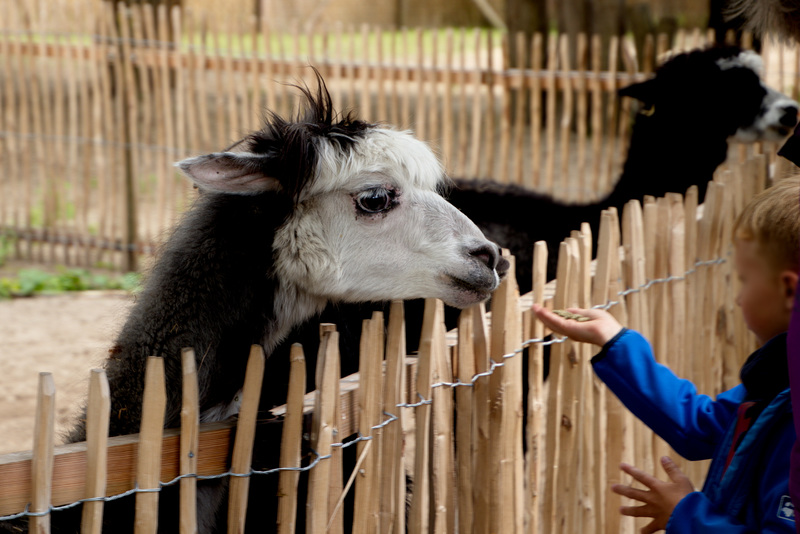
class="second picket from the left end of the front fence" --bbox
[81,369,111,534]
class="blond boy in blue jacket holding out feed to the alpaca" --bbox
[534,178,800,534]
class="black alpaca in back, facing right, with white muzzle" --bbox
[448,47,798,292]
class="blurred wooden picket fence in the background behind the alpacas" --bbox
[0,0,800,269]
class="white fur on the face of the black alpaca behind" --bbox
[717,50,798,143]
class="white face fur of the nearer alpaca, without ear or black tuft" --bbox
[273,128,499,314]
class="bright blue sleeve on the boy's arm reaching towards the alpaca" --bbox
[592,329,745,460]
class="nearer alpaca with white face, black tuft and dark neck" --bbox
[15,79,508,533]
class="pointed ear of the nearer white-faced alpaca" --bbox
[175,152,281,195]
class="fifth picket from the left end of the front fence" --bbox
[228,345,266,534]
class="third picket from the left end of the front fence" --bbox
[134,356,167,534]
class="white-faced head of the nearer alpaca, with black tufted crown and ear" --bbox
[178,73,508,307]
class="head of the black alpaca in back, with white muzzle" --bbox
[620,47,798,143]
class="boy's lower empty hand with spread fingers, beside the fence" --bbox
[611,456,694,534]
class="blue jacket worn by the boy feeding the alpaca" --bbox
[592,329,795,534]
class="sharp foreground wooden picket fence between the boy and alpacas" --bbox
[0,156,766,534]
